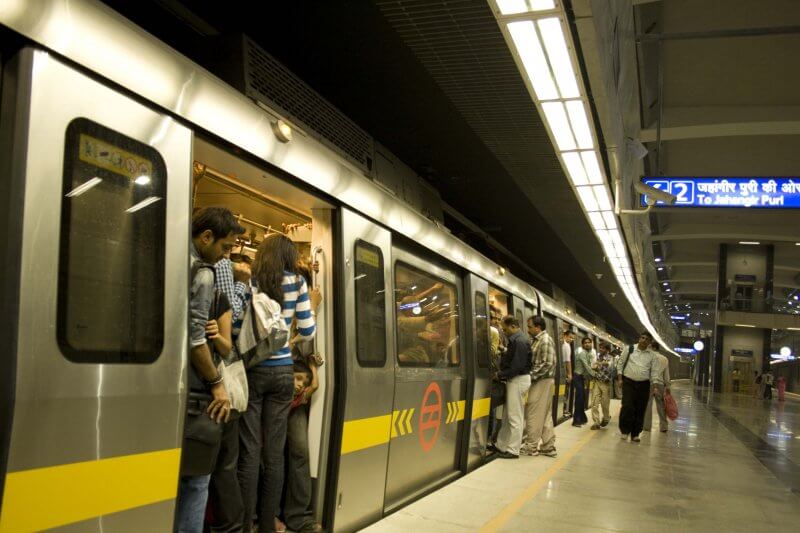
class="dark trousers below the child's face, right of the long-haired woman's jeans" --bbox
[283,405,314,531]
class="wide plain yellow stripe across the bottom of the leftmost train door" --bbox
[0,448,181,533]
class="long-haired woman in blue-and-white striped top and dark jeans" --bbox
[238,234,316,531]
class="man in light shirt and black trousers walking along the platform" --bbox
[617,331,658,442]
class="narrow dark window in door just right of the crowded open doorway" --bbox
[355,240,386,367]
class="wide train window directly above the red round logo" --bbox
[395,263,461,367]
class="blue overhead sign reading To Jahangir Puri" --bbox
[642,176,800,209]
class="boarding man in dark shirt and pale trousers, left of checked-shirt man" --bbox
[497,315,531,459]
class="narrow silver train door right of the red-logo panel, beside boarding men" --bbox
[466,274,492,470]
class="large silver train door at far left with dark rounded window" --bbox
[0,48,192,531]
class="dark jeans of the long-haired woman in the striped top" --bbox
[239,365,294,533]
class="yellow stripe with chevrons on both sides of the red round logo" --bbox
[341,398,490,455]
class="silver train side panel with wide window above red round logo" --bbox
[384,246,469,512]
